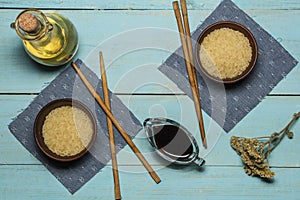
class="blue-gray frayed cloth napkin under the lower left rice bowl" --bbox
[9,60,142,194]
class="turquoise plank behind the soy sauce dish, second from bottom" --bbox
[0,95,300,168]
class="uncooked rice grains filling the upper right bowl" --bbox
[199,28,252,79]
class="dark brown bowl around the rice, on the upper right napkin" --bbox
[195,21,258,84]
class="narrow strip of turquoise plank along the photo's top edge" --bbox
[0,0,300,10]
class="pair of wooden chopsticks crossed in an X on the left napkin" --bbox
[71,52,161,199]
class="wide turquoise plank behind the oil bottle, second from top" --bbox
[0,9,300,94]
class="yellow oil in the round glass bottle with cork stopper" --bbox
[11,11,78,66]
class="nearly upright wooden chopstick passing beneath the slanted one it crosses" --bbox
[99,51,122,200]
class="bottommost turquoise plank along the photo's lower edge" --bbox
[0,165,300,200]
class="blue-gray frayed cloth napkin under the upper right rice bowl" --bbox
[159,0,298,132]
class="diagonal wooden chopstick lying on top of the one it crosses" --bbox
[71,62,161,183]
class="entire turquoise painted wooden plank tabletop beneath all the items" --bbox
[0,0,300,200]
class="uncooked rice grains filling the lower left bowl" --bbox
[42,106,93,156]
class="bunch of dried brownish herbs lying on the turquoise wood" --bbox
[230,112,300,178]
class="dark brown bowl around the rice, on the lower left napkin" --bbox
[34,99,97,162]
